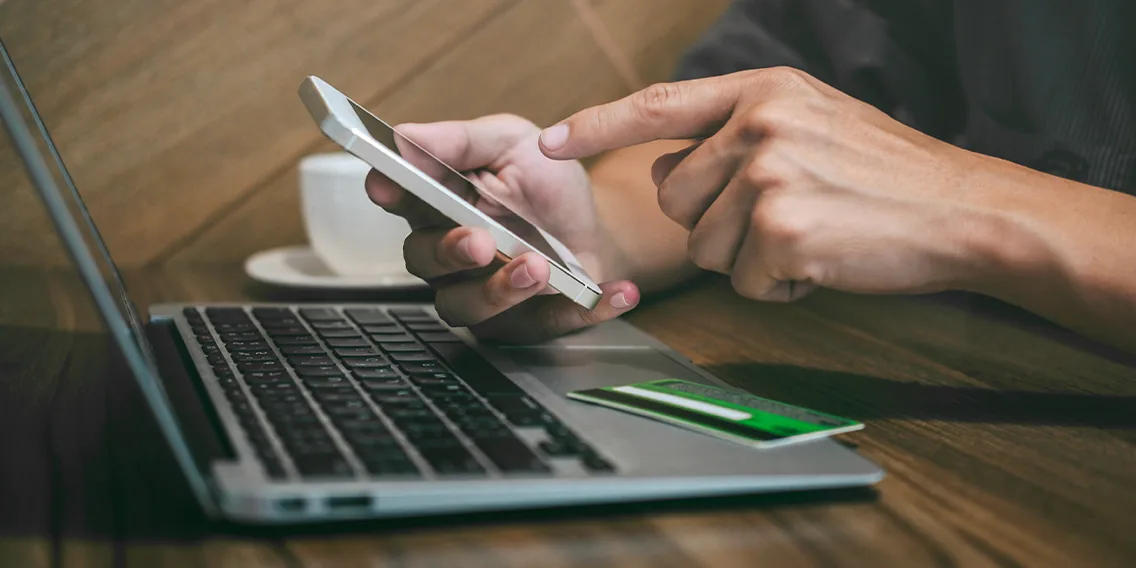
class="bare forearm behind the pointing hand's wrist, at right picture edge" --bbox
[958,154,1136,352]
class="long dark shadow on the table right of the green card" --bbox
[710,364,1136,429]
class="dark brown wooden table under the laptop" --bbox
[0,268,1136,568]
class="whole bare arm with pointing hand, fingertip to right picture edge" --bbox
[541,69,1136,351]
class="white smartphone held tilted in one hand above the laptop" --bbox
[300,76,603,309]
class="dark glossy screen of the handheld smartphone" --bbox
[348,99,575,274]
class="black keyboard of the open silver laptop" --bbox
[184,307,615,479]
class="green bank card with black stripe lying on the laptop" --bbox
[568,378,863,448]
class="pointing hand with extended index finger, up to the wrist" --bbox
[541,68,997,301]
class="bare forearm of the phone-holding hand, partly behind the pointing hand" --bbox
[591,141,699,293]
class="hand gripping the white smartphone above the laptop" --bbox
[367,115,640,342]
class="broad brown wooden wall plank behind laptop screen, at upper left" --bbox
[0,0,507,266]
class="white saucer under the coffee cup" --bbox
[244,245,426,290]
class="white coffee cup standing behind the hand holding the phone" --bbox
[300,152,410,276]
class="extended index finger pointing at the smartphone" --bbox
[541,73,757,160]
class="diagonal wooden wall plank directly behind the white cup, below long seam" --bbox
[170,0,627,262]
